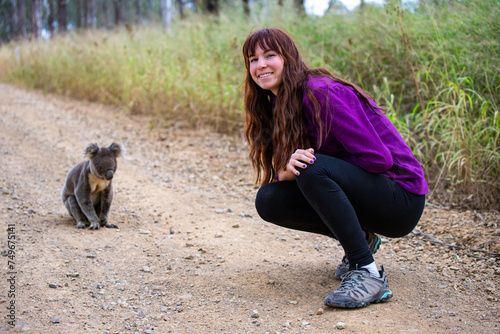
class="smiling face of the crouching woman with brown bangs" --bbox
[248,44,285,95]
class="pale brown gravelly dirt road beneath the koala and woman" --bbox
[0,84,500,334]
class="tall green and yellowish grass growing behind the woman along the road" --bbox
[0,0,500,209]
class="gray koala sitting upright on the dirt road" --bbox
[62,143,122,230]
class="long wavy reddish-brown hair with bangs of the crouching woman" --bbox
[242,28,373,184]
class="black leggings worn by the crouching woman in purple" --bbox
[255,154,425,269]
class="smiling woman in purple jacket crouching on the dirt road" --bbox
[243,28,428,308]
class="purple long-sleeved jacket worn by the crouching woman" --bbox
[303,76,428,195]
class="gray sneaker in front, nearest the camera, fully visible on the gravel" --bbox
[325,267,392,308]
